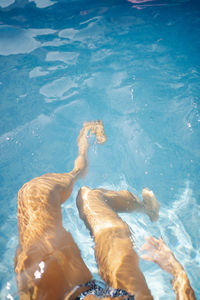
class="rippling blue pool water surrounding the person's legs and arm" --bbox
[0,0,200,300]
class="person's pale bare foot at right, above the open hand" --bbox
[142,188,160,222]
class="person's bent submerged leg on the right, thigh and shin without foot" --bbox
[77,187,156,300]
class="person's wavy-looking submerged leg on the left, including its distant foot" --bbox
[15,121,106,300]
